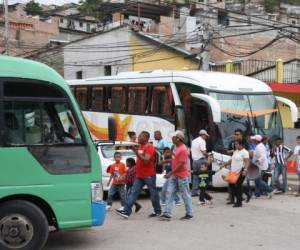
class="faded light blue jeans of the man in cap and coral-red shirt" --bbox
[164,176,193,216]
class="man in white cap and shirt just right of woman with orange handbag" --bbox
[250,135,273,198]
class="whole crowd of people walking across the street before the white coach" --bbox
[108,129,300,220]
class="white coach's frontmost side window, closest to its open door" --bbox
[151,86,174,116]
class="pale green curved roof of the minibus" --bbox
[0,56,65,87]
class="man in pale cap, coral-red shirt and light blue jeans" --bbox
[160,130,193,220]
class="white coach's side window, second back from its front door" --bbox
[128,87,147,114]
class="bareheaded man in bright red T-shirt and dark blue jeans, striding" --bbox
[115,131,161,219]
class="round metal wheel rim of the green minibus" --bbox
[0,214,34,249]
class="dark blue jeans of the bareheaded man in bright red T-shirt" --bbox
[124,176,161,215]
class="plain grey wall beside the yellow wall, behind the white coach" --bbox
[63,28,131,80]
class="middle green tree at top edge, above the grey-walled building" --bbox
[78,0,103,19]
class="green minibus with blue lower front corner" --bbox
[0,56,105,250]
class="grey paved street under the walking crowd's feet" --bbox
[45,192,300,250]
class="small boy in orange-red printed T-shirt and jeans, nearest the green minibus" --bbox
[106,152,126,210]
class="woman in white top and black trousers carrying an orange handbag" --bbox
[223,140,250,207]
